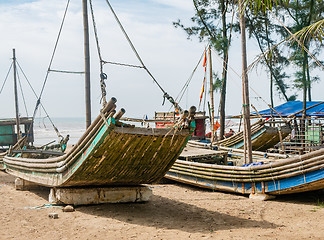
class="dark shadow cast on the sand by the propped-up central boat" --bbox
[77,196,277,233]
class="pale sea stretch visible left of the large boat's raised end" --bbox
[34,117,86,146]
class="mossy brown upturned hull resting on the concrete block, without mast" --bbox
[4,118,194,187]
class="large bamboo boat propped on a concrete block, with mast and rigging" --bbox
[3,0,195,188]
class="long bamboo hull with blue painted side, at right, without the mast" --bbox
[165,149,324,195]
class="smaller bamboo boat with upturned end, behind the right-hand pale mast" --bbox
[214,119,291,151]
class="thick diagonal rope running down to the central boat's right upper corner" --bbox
[106,0,183,113]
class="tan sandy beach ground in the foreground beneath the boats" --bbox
[0,171,324,240]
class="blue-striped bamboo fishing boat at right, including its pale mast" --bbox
[166,6,324,199]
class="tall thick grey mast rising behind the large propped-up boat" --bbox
[82,0,91,128]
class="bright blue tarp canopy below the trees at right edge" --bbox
[251,101,324,117]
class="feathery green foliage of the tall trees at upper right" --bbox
[173,0,324,105]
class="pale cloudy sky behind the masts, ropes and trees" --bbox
[0,0,323,118]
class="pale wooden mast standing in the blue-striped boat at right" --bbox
[239,0,252,163]
